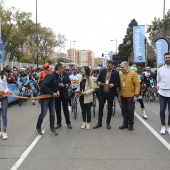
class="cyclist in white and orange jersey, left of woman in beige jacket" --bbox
[69,68,81,111]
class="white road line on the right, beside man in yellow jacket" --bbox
[135,112,170,151]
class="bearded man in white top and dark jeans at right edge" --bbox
[157,52,170,135]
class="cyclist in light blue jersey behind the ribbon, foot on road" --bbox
[17,71,35,105]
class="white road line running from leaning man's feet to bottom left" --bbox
[11,130,45,170]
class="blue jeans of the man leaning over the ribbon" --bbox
[36,97,55,128]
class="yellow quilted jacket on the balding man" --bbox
[119,69,140,97]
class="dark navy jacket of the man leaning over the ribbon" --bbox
[40,71,59,95]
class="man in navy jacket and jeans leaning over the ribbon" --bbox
[36,63,64,135]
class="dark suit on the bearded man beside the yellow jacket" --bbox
[97,69,120,124]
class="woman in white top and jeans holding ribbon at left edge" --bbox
[0,71,10,140]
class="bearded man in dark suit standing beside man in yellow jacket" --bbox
[93,60,120,129]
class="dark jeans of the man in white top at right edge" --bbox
[159,95,170,126]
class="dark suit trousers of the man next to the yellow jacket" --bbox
[98,92,113,124]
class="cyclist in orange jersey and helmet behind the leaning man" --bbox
[37,63,53,86]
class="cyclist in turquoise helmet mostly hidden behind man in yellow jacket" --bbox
[130,67,148,119]
